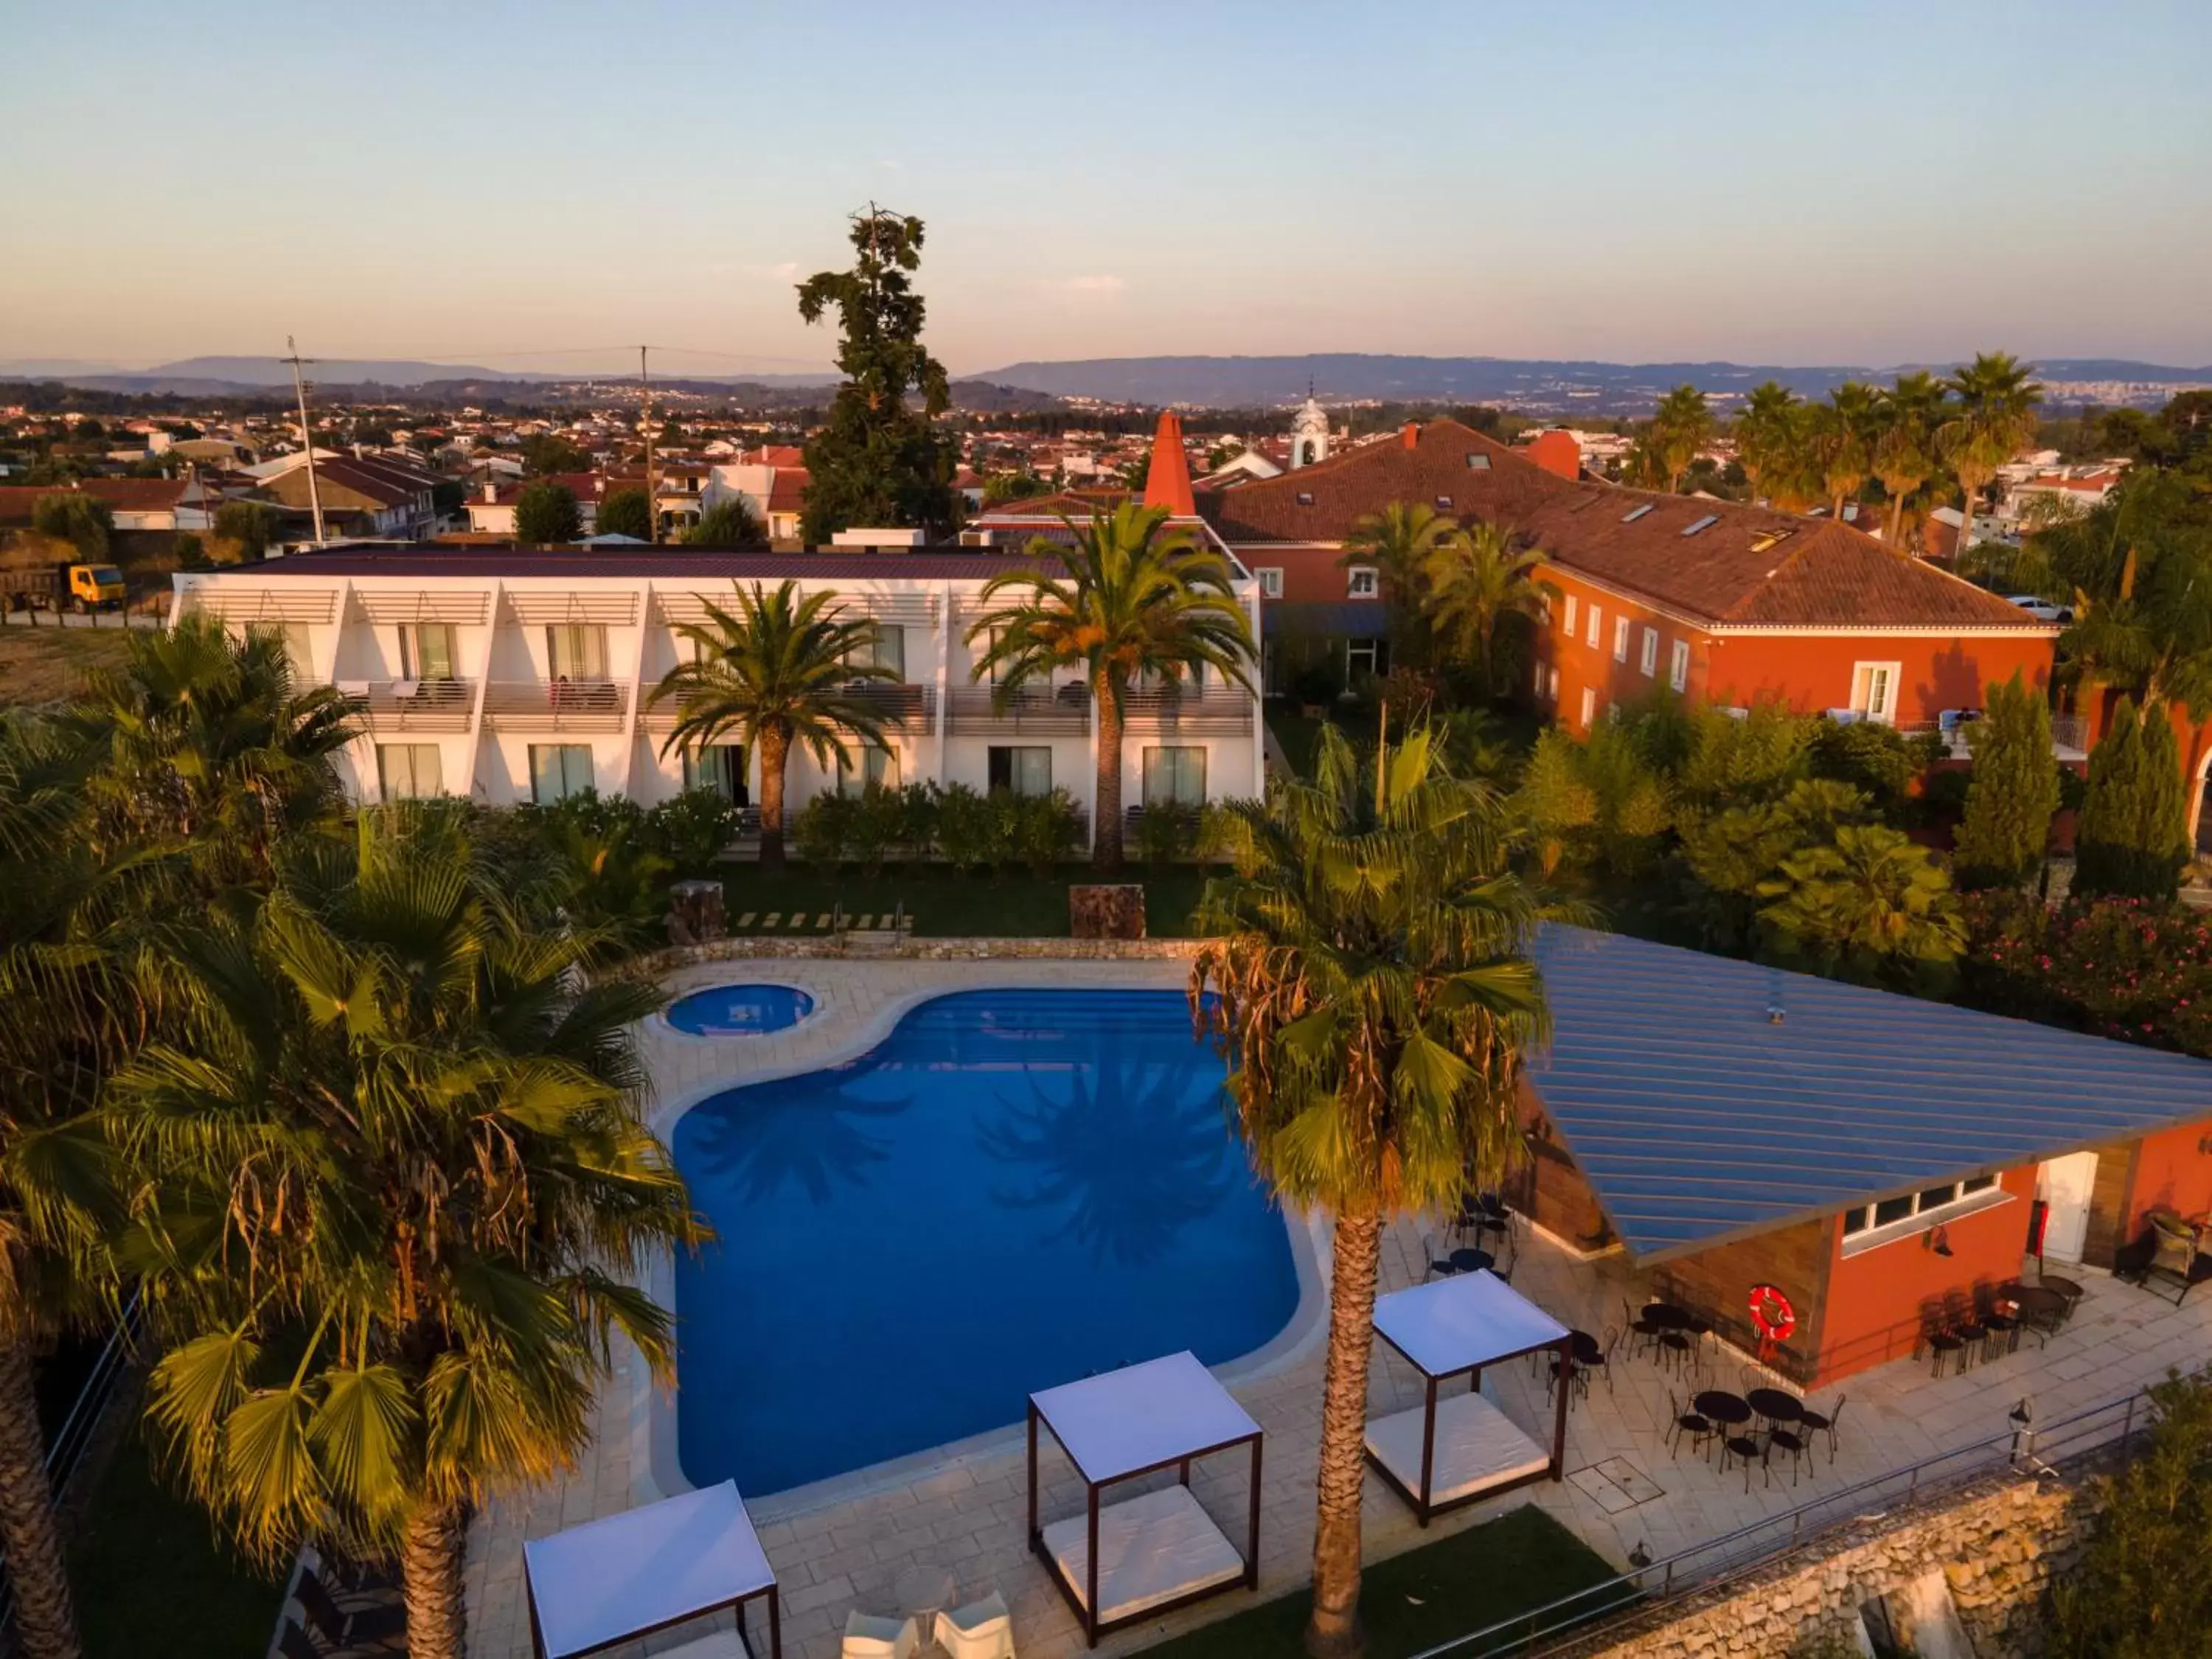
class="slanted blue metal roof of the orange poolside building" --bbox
[1528,927,2212,1256]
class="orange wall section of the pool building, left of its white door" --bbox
[1820,1159,2026,1382]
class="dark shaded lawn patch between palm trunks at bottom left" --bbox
[69,1433,283,1659]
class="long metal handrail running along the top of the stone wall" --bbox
[1411,1389,2150,1659]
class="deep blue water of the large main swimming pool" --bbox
[675,991,1298,1495]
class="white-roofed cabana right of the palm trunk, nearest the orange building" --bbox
[1367,1272,1575,1526]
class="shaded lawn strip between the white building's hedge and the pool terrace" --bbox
[719,865,1208,938]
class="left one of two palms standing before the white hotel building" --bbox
[648,577,898,867]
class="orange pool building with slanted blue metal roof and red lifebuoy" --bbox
[1506,927,2212,1385]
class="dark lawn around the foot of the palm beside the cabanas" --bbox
[1146,1504,1613,1659]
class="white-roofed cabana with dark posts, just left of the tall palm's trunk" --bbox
[1029,1352,1261,1648]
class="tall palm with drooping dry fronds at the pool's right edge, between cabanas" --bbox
[1190,728,1544,1655]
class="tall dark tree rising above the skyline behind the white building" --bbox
[799,206,958,546]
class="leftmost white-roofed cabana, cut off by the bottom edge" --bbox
[522,1480,783,1659]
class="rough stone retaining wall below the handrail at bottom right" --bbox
[1551,1475,2090,1659]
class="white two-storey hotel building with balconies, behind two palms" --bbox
[173,538,1263,836]
